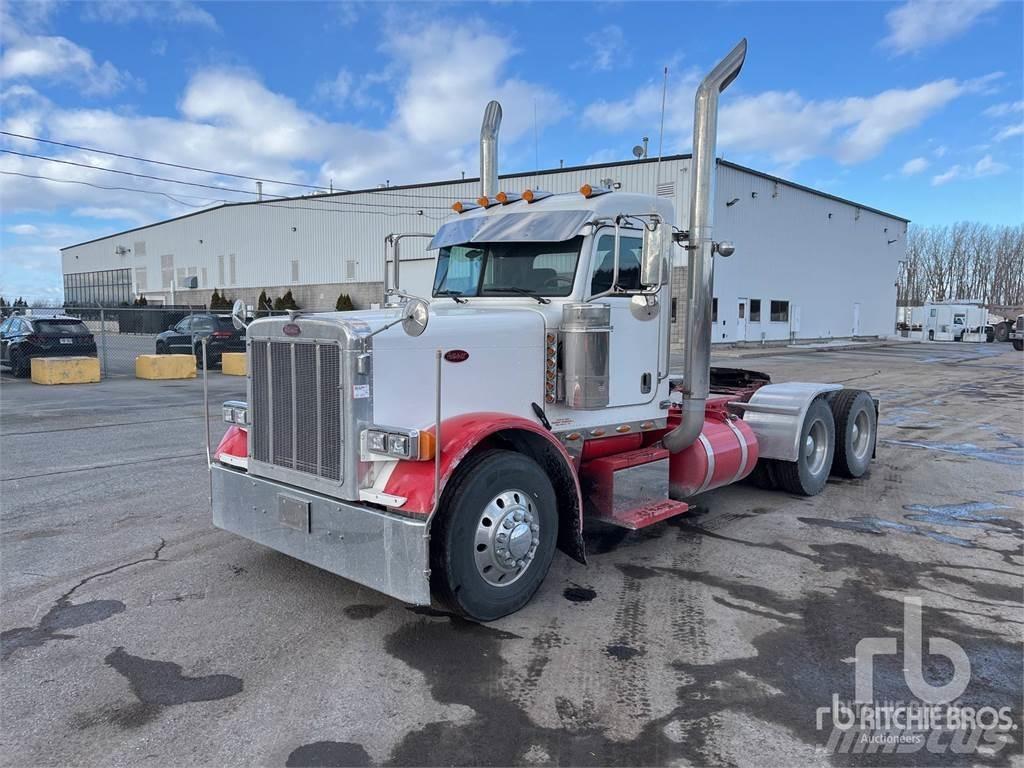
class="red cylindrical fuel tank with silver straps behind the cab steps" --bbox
[669,400,758,501]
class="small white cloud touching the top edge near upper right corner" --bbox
[882,0,998,55]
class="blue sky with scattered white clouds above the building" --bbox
[0,0,1024,301]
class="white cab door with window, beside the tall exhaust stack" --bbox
[587,227,666,407]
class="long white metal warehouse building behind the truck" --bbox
[61,155,907,343]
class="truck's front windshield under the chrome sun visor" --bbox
[434,237,583,296]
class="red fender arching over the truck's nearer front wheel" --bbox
[384,412,583,529]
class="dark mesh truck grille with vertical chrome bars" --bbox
[249,340,344,482]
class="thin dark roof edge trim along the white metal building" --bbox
[60,153,910,251]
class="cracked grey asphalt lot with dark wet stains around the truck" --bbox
[0,344,1024,766]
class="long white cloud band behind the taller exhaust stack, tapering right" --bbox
[584,72,1001,169]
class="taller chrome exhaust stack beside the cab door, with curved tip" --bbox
[663,38,746,454]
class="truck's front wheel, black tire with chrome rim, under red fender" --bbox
[430,451,558,622]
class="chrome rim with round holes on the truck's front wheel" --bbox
[473,488,541,587]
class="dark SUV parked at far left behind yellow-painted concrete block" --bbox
[0,315,96,376]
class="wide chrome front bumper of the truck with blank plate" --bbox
[210,464,430,605]
